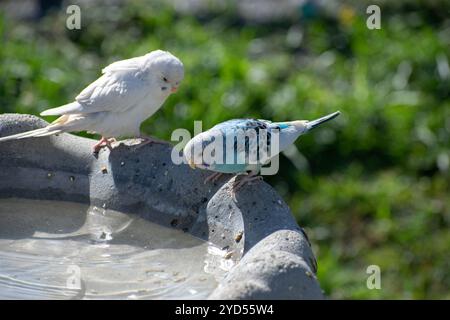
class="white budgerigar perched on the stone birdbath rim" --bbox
[0,50,184,152]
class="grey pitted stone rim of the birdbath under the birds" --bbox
[0,114,323,299]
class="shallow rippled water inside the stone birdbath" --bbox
[0,199,232,299]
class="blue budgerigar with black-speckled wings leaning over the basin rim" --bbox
[183,111,340,190]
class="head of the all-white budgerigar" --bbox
[147,50,184,95]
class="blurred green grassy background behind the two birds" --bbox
[0,0,450,299]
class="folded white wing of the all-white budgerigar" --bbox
[41,57,150,115]
